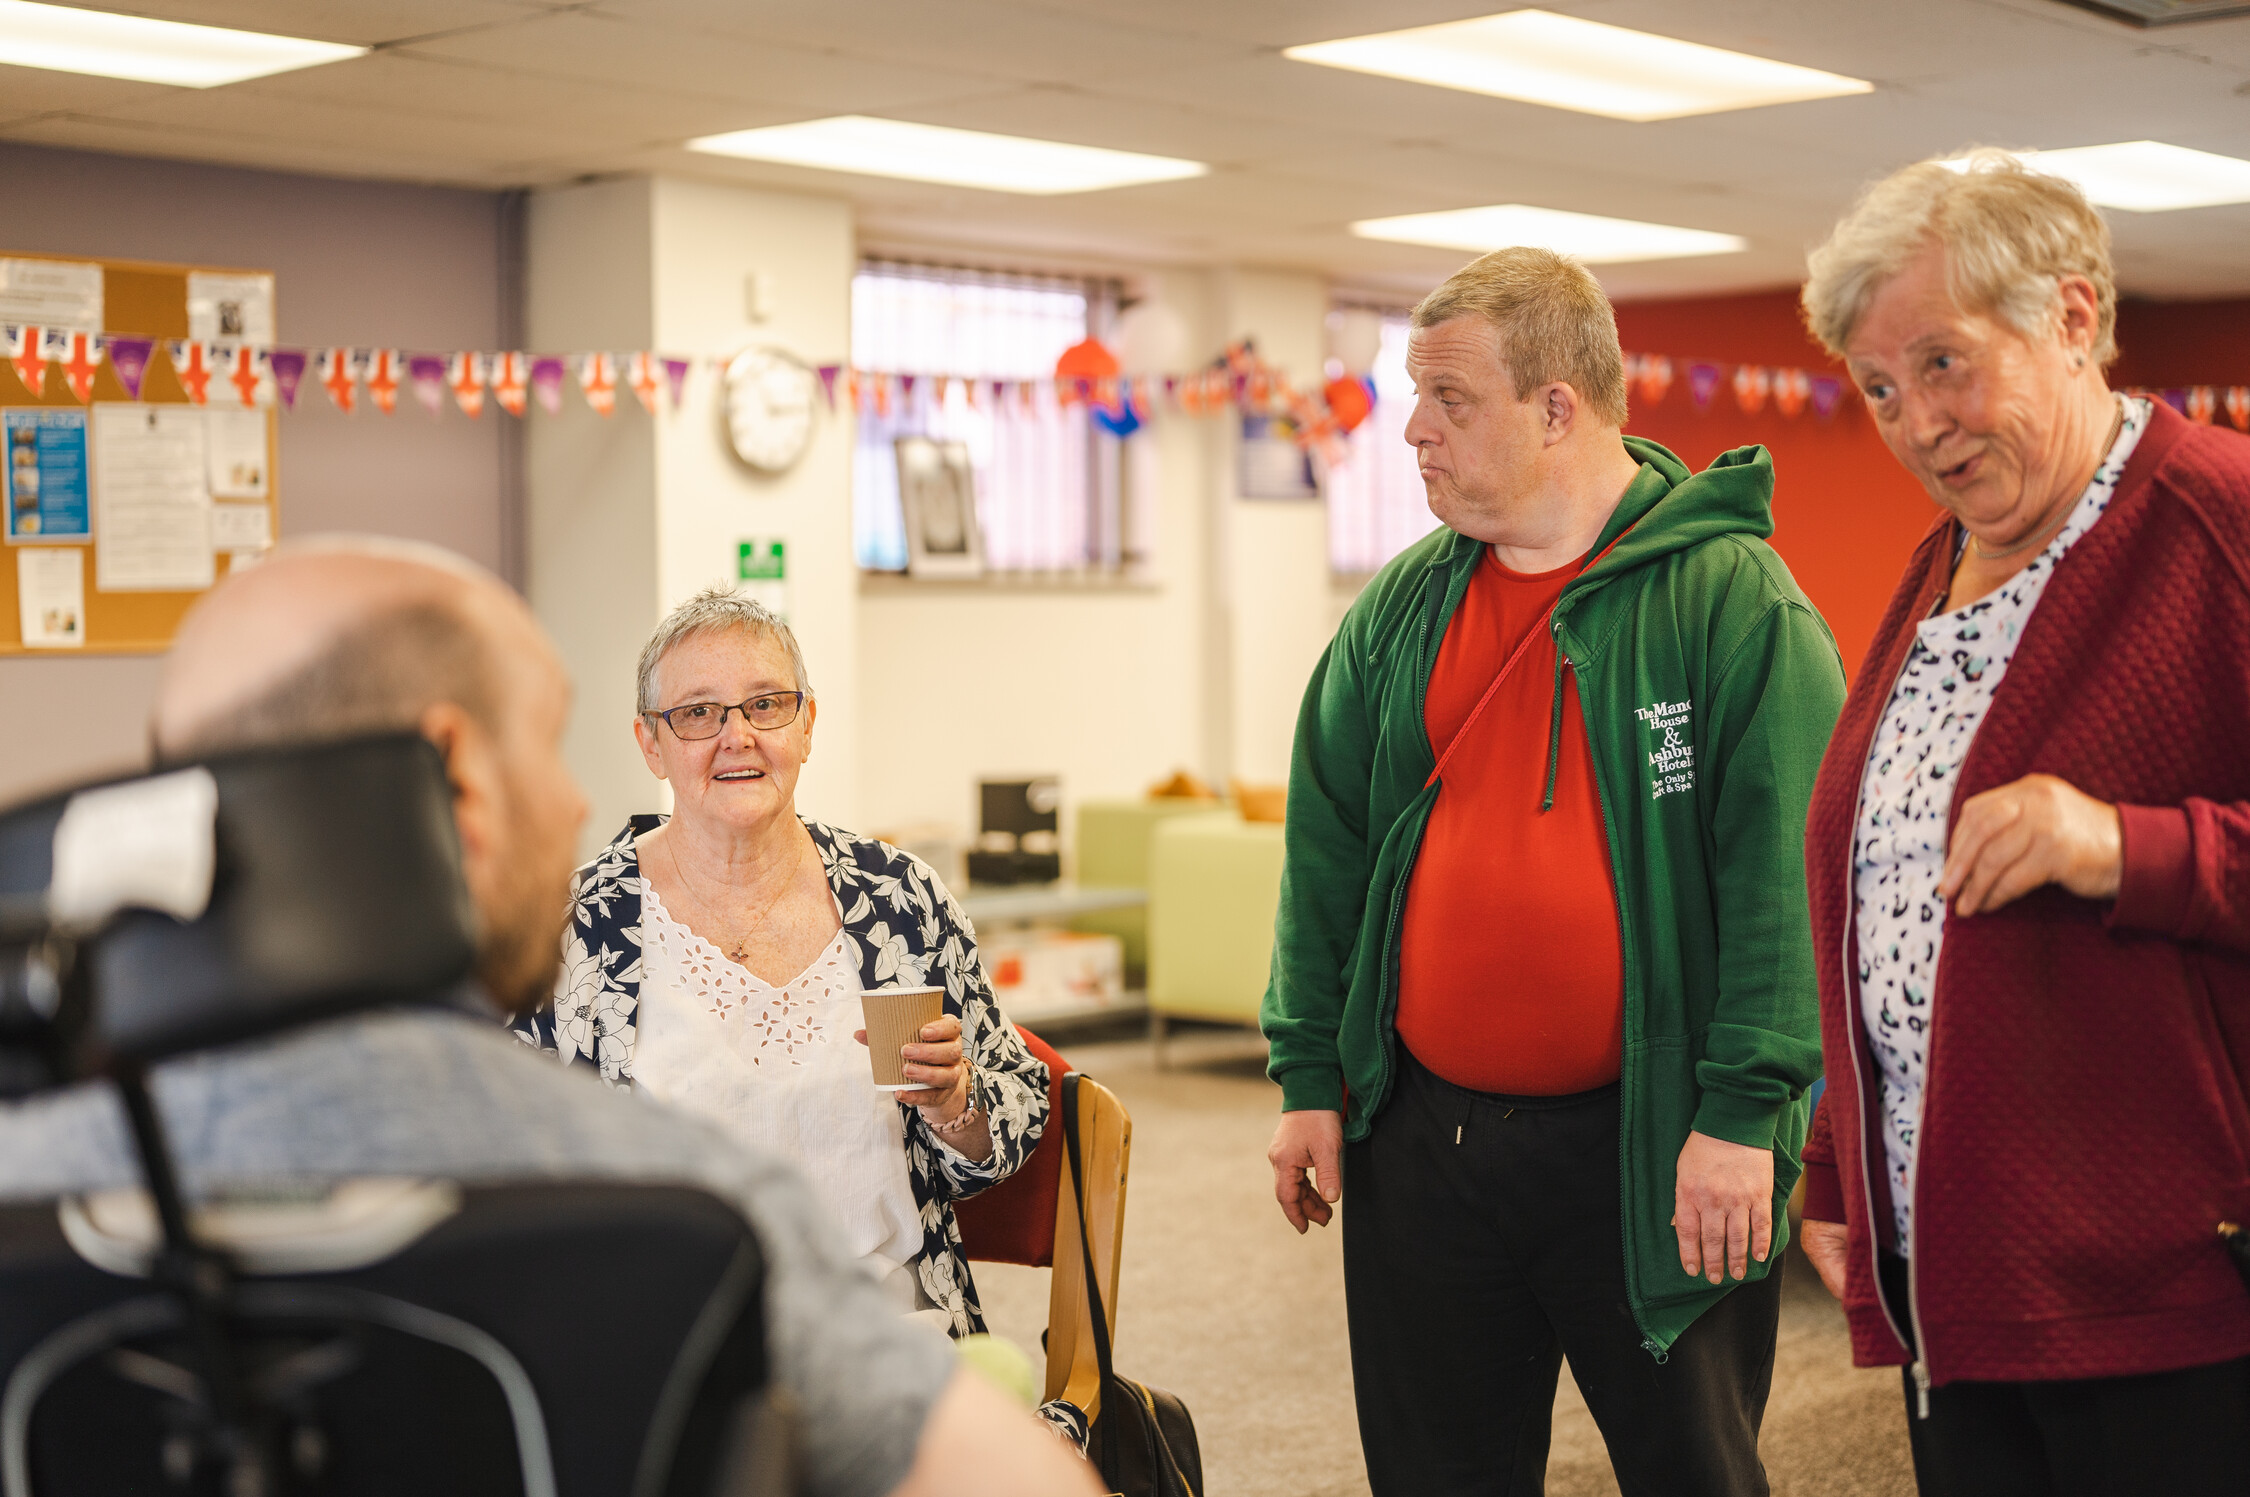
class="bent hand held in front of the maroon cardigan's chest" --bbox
[1937,774,2124,914]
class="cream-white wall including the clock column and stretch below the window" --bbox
[527,178,1337,844]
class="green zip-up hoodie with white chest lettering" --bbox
[1260,437,1843,1357]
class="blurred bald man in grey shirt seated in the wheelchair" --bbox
[0,540,1098,1497]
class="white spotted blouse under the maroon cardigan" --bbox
[1852,396,2149,1256]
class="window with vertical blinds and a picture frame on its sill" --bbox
[851,261,1134,572]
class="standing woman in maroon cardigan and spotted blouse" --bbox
[1802,153,2250,1497]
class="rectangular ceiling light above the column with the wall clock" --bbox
[689,115,1211,194]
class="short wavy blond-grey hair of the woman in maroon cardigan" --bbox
[1805,146,2117,365]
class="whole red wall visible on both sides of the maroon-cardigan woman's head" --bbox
[1618,290,2250,673]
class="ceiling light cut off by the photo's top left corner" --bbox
[0,0,367,88]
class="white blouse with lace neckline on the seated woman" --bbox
[635,880,923,1310]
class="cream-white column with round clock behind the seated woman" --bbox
[524,178,857,849]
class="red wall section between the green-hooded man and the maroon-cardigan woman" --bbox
[1618,290,1937,673]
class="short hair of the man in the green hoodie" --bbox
[1413,245,1625,425]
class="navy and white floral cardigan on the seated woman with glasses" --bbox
[511,815,1046,1337]
